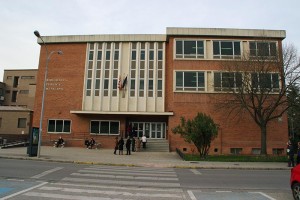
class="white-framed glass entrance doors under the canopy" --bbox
[130,122,166,139]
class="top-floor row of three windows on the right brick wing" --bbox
[175,39,277,59]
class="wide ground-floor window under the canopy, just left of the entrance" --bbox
[90,121,120,135]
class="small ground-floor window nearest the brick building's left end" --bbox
[48,119,71,133]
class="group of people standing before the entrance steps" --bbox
[114,135,147,155]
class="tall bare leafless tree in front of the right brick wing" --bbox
[215,40,300,155]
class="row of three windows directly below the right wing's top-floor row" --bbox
[175,71,280,92]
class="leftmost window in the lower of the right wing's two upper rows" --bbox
[175,71,205,91]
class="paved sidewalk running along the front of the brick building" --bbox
[0,146,290,170]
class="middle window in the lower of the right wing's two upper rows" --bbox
[214,72,242,91]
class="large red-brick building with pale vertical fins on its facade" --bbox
[33,28,288,154]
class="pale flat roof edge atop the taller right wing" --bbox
[167,27,286,39]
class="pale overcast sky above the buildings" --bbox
[0,0,300,81]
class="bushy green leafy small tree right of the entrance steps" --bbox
[172,113,218,158]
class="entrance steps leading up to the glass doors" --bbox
[141,138,170,152]
